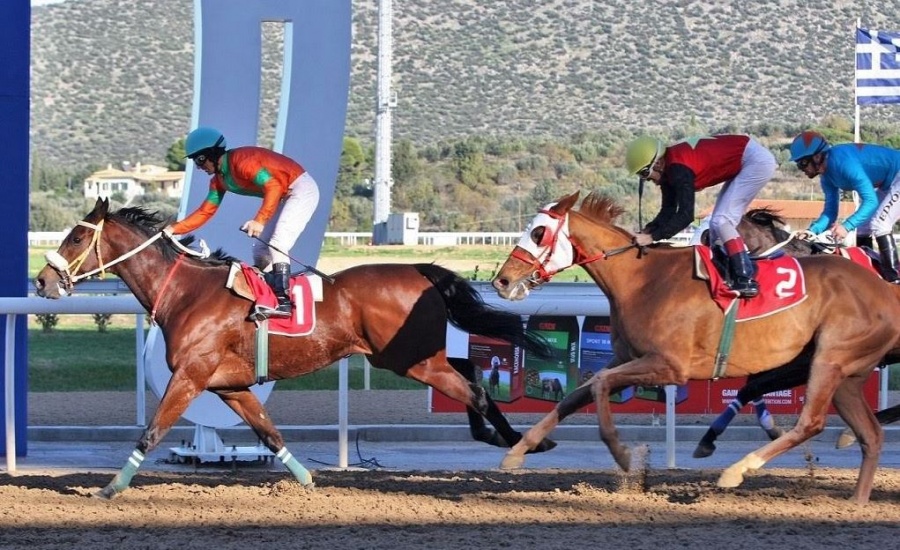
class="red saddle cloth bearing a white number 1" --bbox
[241,263,316,336]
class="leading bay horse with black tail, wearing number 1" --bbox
[34,200,555,498]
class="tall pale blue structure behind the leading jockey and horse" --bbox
[144,0,352,428]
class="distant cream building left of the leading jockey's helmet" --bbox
[84,163,184,204]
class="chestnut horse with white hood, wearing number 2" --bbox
[493,192,900,503]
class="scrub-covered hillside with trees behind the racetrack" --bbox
[31,0,900,231]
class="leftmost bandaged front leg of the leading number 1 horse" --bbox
[94,370,204,499]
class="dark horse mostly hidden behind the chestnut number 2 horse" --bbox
[694,208,900,458]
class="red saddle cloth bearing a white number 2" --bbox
[694,245,807,321]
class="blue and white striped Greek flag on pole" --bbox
[856,28,900,105]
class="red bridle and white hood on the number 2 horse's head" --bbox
[510,208,638,287]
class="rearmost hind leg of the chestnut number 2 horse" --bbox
[832,376,884,504]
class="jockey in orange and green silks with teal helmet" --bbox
[166,127,319,317]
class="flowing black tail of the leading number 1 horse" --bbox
[413,264,553,357]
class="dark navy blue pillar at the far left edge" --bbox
[0,0,31,456]
